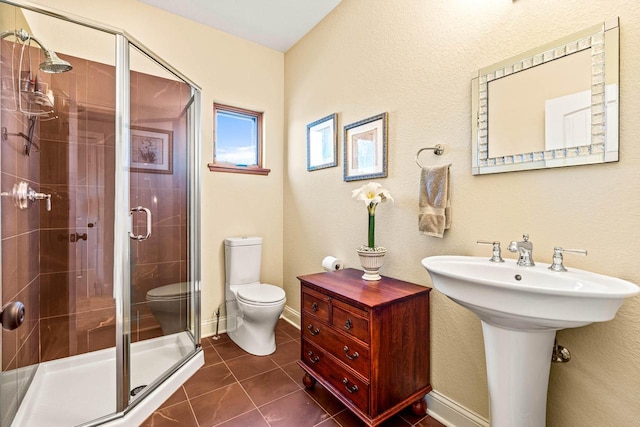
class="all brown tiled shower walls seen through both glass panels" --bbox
[0,41,190,371]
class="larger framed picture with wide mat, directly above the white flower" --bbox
[344,113,387,181]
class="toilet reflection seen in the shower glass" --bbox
[146,282,189,335]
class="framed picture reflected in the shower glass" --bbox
[131,126,173,173]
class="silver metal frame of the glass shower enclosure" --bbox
[0,0,202,426]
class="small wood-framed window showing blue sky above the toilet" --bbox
[209,104,270,175]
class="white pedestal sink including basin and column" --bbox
[422,256,640,427]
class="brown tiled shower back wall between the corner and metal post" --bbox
[40,52,115,362]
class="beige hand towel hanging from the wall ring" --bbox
[418,165,451,238]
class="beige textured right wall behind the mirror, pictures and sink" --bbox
[284,0,640,427]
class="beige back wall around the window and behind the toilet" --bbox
[30,0,284,334]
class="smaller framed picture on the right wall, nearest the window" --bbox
[307,113,338,171]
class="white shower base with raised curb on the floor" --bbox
[12,332,204,427]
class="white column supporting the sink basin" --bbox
[482,321,556,427]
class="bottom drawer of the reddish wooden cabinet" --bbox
[302,339,369,413]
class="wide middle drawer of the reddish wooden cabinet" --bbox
[302,313,370,378]
